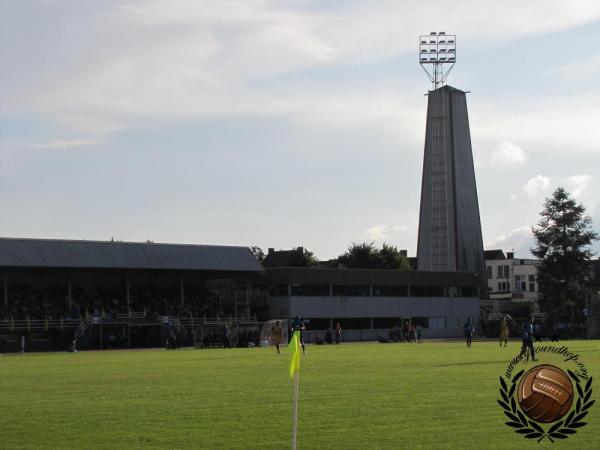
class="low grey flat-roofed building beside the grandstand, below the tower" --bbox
[253,267,480,341]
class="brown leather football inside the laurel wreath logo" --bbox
[517,365,573,423]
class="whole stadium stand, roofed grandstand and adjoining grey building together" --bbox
[0,238,480,353]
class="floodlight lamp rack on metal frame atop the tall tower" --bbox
[419,31,456,90]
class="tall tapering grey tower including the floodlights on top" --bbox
[417,32,488,298]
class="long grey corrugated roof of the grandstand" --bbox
[0,238,263,272]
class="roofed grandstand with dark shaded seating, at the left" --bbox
[0,238,263,353]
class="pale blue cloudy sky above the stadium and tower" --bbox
[0,0,600,259]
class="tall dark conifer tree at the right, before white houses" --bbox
[531,187,598,323]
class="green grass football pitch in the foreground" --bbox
[0,341,600,450]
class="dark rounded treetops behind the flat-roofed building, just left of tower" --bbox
[337,242,410,270]
